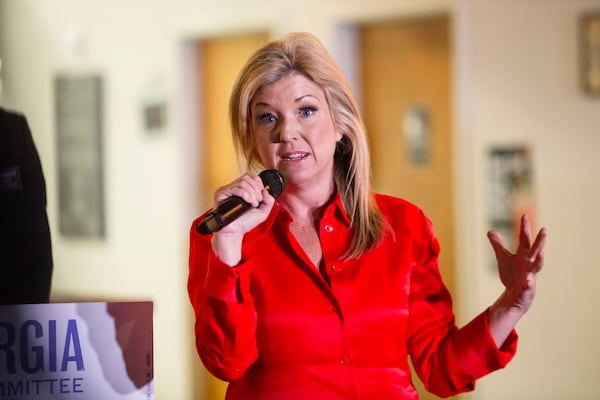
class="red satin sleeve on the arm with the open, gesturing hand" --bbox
[408,212,517,397]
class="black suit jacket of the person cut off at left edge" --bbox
[0,108,53,304]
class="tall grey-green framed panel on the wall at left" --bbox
[55,74,105,238]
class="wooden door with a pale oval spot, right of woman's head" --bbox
[359,15,454,400]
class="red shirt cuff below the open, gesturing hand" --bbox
[454,310,518,379]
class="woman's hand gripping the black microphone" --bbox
[212,173,275,266]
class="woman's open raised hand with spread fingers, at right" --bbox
[488,215,546,314]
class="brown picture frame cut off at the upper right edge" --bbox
[579,10,600,96]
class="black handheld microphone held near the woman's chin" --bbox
[196,169,285,235]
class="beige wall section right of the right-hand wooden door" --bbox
[455,0,600,400]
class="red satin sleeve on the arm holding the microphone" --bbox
[188,220,257,381]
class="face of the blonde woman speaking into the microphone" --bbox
[251,74,342,189]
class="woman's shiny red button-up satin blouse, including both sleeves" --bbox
[188,195,517,400]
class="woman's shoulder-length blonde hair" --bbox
[229,33,385,258]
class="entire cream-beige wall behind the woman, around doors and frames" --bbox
[0,0,600,400]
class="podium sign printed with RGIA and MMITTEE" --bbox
[0,302,154,400]
